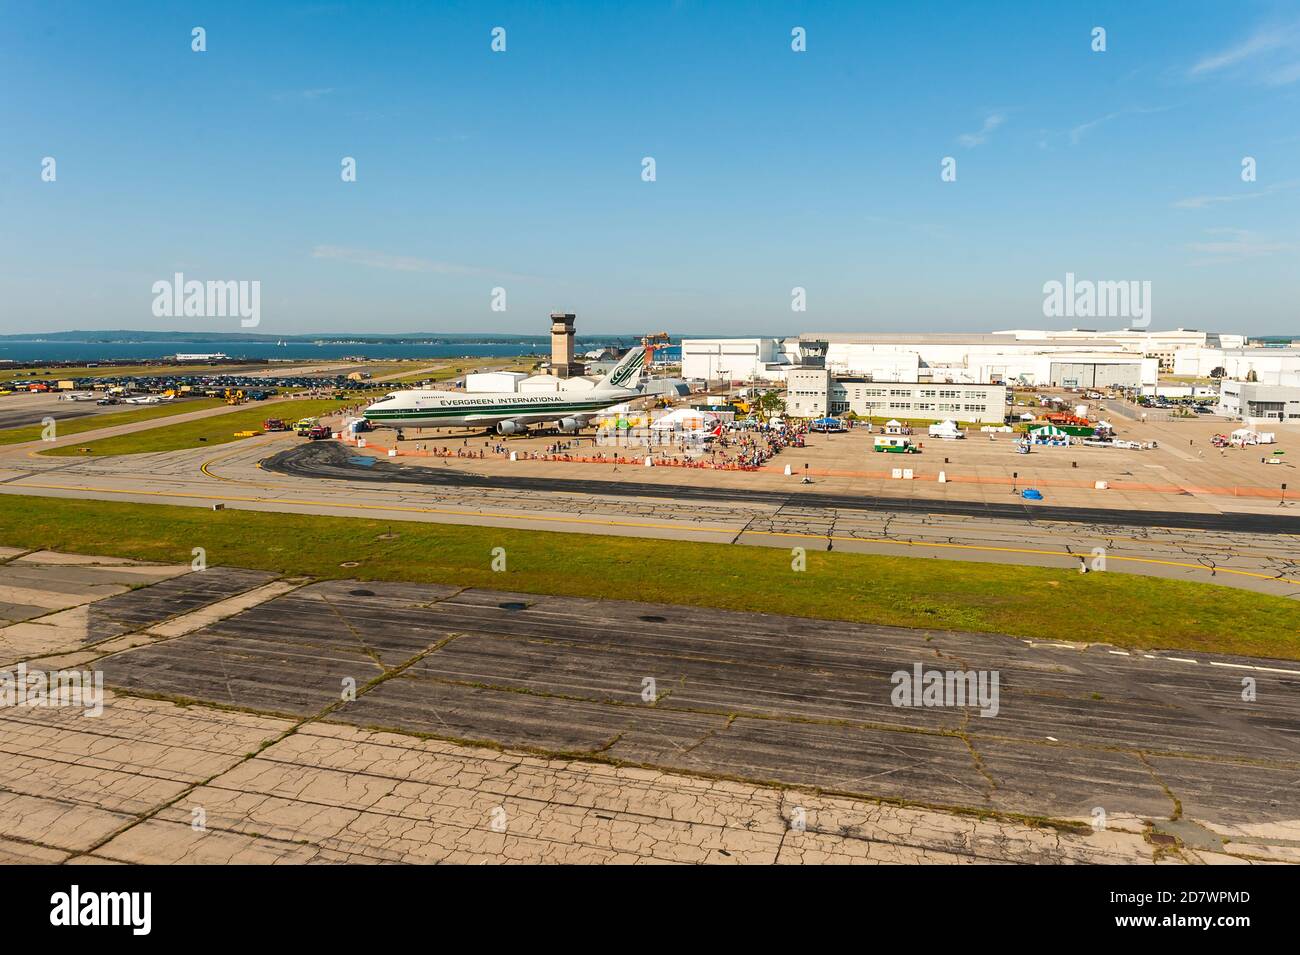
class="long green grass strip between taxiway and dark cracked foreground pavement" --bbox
[0,495,1300,659]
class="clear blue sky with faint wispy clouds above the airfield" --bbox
[0,0,1300,335]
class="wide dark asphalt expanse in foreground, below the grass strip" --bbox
[91,572,1300,824]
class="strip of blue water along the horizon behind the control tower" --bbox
[0,340,681,361]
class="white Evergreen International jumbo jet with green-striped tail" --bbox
[361,344,653,434]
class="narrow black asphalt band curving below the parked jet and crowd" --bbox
[261,442,1300,534]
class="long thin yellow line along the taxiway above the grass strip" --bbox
[10,476,1300,583]
